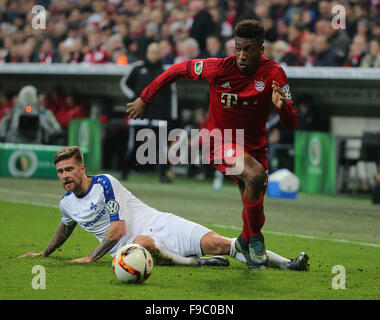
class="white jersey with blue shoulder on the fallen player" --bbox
[59,174,171,255]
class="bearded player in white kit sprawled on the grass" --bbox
[22,146,308,271]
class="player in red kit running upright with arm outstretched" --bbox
[127,20,298,269]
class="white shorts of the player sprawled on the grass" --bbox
[127,213,212,257]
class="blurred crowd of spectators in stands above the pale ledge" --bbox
[0,0,380,67]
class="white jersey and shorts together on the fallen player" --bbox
[59,174,211,257]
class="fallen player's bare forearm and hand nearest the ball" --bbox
[70,220,125,263]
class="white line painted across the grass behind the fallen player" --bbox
[1,199,380,248]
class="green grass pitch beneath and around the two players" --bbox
[0,174,380,300]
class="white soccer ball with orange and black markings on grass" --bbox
[112,243,153,283]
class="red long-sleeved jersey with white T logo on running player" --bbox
[140,56,297,153]
